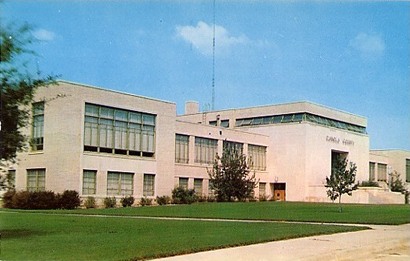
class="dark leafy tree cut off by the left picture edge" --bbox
[0,20,55,188]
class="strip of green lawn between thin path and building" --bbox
[44,201,410,225]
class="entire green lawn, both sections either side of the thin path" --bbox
[0,202,410,260]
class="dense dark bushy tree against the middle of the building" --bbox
[208,146,258,201]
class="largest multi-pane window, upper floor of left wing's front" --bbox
[84,103,156,157]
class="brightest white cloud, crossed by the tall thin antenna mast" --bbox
[177,21,250,55]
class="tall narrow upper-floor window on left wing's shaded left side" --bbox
[31,102,44,151]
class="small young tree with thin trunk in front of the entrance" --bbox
[325,155,357,212]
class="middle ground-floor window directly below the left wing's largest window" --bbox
[107,172,134,196]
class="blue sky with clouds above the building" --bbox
[0,0,410,150]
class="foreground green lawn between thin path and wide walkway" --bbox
[0,211,364,260]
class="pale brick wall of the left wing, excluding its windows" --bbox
[14,82,176,197]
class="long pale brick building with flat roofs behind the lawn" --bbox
[9,81,410,203]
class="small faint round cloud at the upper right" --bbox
[349,33,386,59]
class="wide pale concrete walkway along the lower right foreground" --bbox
[157,224,410,261]
